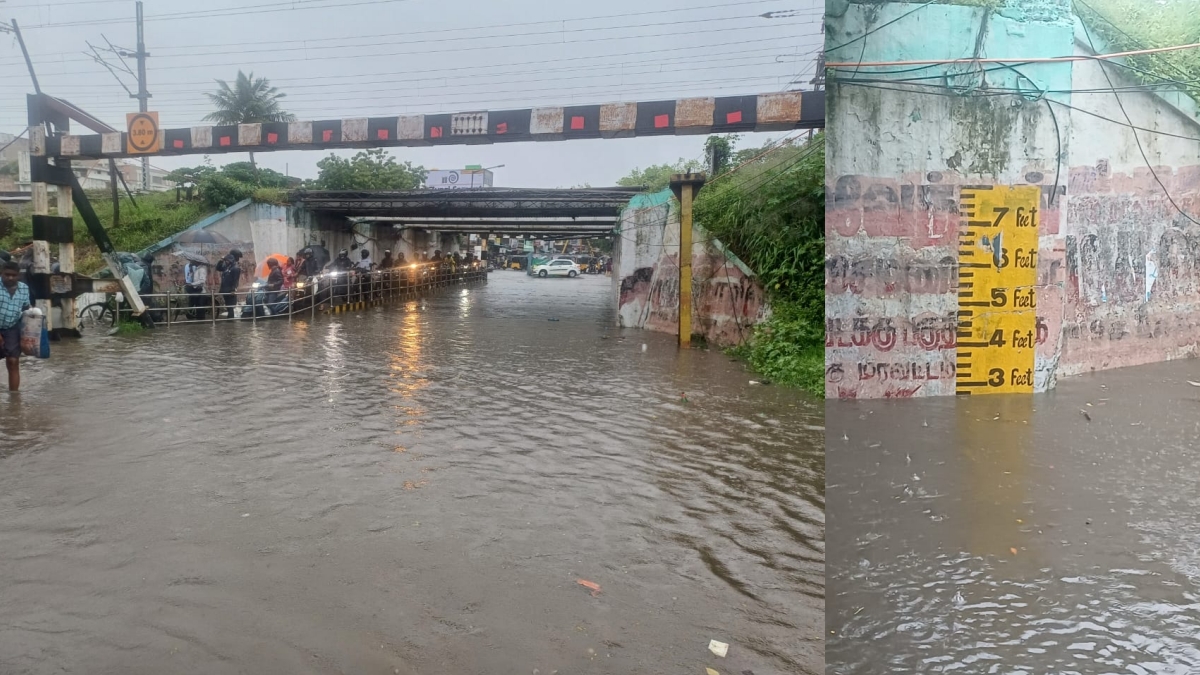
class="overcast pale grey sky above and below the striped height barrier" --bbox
[0,0,824,187]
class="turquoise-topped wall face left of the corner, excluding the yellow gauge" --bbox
[826,4,1072,398]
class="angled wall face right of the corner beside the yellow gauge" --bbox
[1061,38,1200,375]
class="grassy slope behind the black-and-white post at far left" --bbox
[0,190,216,274]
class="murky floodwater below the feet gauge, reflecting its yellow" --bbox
[826,360,1200,674]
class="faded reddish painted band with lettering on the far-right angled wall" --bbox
[1062,161,1200,374]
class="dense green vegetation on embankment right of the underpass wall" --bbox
[696,135,824,396]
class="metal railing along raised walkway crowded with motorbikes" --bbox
[94,262,487,327]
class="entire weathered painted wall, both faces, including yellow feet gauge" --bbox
[826,1,1200,398]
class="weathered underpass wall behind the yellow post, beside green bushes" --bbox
[613,190,768,346]
